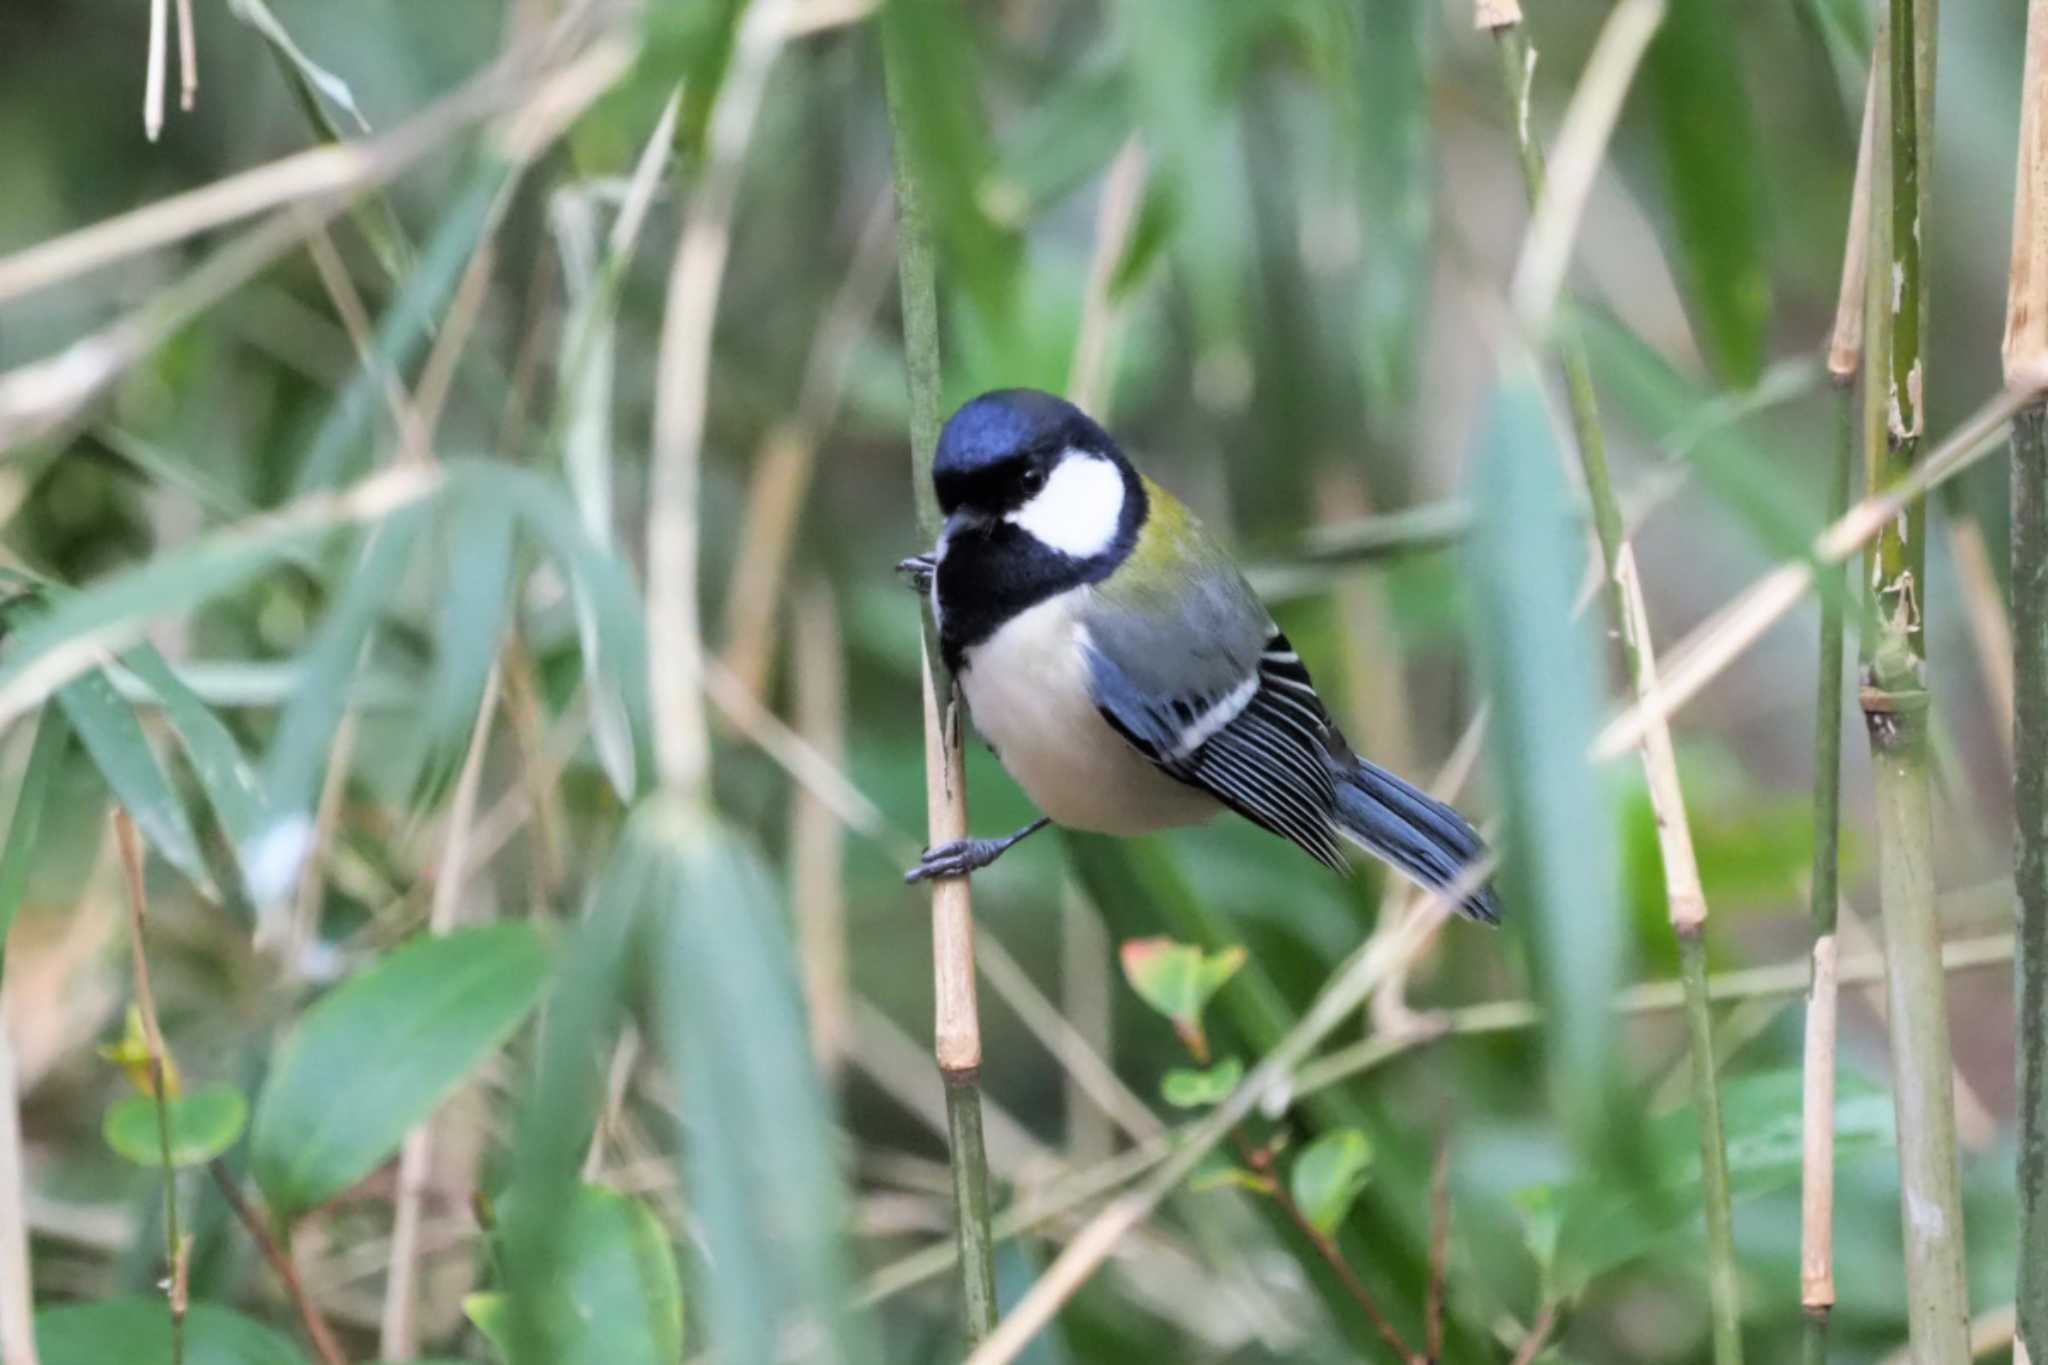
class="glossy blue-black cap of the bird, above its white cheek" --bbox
[932,389,1126,518]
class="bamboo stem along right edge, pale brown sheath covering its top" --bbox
[2005,0,2048,1359]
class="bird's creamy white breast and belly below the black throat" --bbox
[961,587,1219,835]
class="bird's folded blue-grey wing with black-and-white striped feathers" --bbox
[1081,581,1346,870]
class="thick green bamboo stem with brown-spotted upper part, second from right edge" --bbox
[1862,0,1968,1365]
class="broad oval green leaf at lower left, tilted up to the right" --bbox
[250,923,547,1218]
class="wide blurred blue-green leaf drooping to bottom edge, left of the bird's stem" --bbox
[627,796,872,1361]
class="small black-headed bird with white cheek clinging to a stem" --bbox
[901,389,1499,923]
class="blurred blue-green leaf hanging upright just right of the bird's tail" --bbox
[1468,354,1628,1160]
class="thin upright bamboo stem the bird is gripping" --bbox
[883,16,995,1345]
